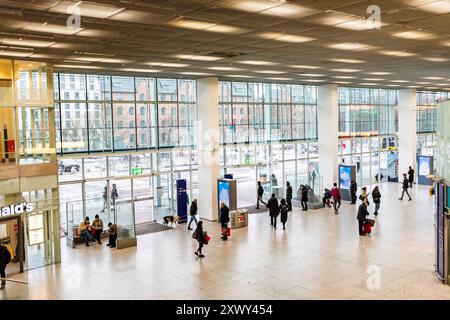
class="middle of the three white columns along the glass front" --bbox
[317,84,339,189]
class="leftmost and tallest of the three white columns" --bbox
[196,78,220,221]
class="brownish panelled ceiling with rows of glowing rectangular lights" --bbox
[0,0,450,90]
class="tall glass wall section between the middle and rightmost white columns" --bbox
[338,87,398,185]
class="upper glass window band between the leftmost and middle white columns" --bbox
[219,81,317,144]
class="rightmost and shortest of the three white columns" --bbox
[398,89,417,181]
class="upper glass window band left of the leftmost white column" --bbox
[55,73,196,154]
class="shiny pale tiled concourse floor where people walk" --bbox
[5,183,450,299]
